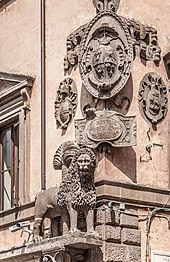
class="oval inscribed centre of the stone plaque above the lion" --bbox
[86,118,123,141]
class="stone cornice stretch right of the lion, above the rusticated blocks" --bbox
[96,180,170,208]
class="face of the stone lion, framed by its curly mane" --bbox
[77,154,92,176]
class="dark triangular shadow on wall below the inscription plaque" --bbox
[98,147,137,183]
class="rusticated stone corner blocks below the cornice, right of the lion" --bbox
[96,205,141,261]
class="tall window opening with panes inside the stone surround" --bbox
[0,122,19,210]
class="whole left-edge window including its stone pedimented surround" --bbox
[0,72,33,211]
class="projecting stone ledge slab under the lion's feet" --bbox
[0,232,102,262]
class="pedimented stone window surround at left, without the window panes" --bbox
[0,72,34,212]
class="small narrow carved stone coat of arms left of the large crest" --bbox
[55,77,77,129]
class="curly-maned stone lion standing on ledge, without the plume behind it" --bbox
[33,148,96,241]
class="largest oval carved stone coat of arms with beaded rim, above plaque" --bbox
[79,11,133,99]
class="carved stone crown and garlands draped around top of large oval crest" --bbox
[64,3,161,78]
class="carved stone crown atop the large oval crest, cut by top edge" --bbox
[93,0,120,13]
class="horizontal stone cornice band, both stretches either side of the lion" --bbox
[0,180,170,229]
